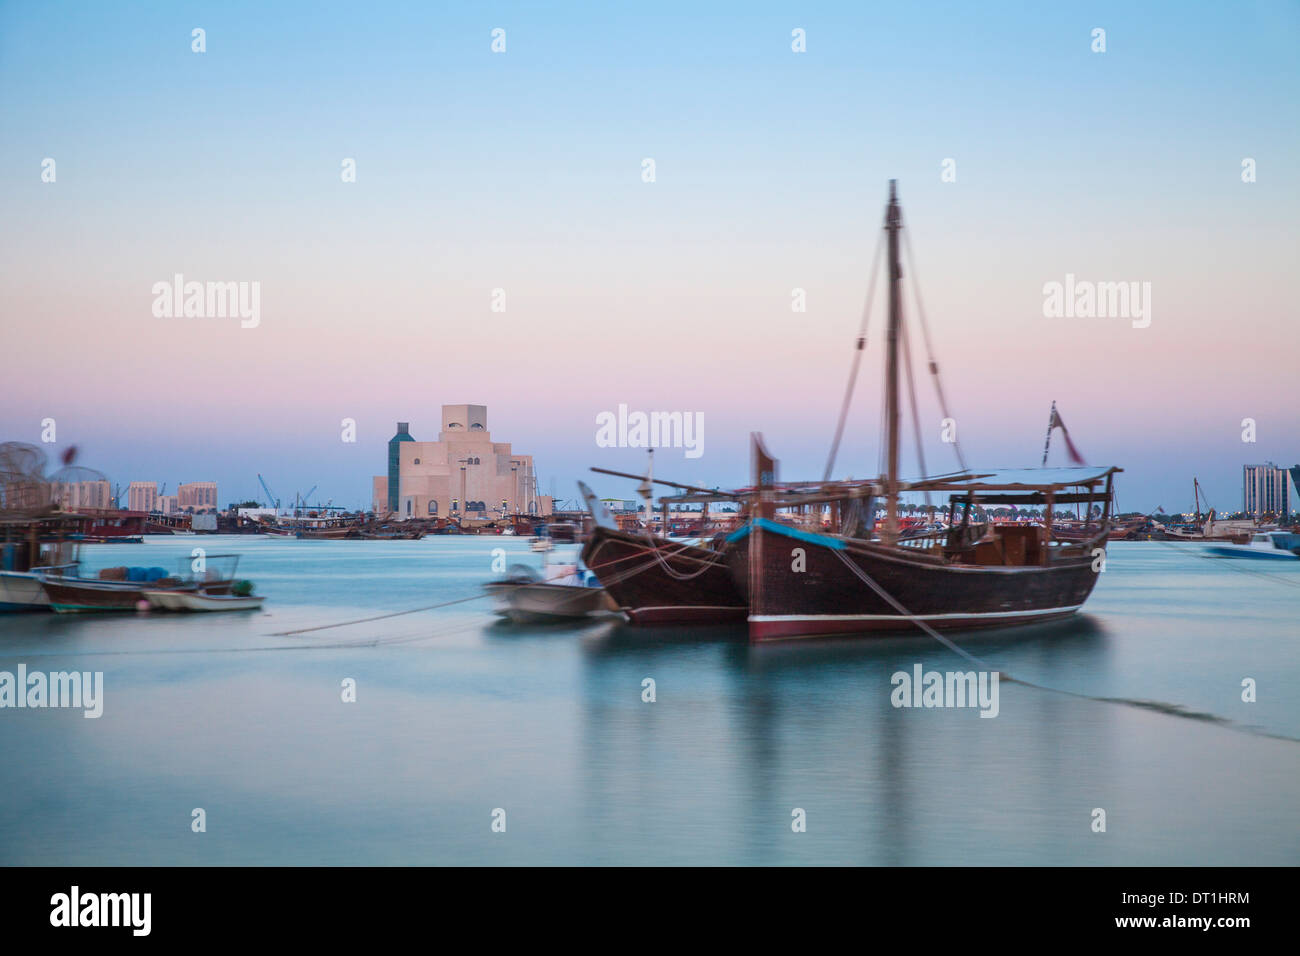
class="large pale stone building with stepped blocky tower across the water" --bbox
[372,405,549,519]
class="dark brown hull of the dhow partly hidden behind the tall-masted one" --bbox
[582,528,749,624]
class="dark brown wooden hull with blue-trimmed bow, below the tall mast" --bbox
[727,527,1097,641]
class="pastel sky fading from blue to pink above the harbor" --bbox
[0,1,1300,510]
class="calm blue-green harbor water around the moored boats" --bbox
[0,536,1300,865]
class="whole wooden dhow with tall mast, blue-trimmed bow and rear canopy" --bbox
[725,182,1121,641]
